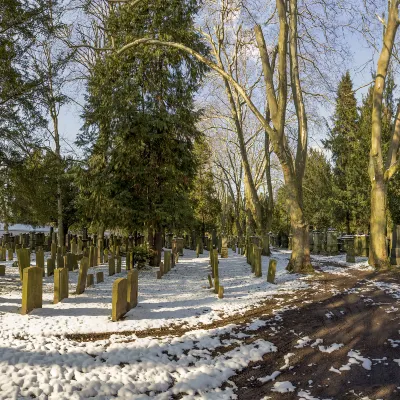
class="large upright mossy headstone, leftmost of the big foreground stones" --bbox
[21,267,43,315]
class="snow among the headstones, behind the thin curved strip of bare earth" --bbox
[0,249,309,335]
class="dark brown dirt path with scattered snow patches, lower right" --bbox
[232,271,400,400]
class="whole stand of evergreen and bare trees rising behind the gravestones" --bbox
[0,0,400,272]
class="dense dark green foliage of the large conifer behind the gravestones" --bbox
[78,0,209,232]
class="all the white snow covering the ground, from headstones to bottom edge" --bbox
[0,250,378,400]
